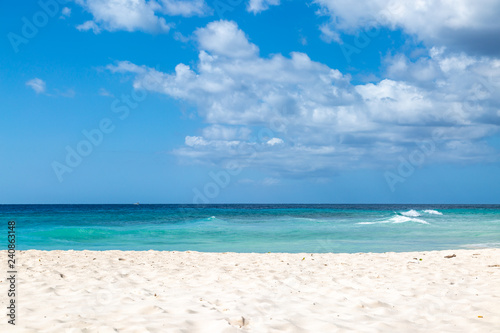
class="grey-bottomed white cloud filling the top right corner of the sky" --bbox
[315,0,500,55]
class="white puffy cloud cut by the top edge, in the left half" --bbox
[76,0,210,33]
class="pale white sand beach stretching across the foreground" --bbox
[0,249,500,333]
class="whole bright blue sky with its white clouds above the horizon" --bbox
[0,0,500,204]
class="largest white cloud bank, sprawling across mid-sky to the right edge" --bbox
[108,21,500,178]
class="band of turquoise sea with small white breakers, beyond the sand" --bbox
[0,205,500,253]
